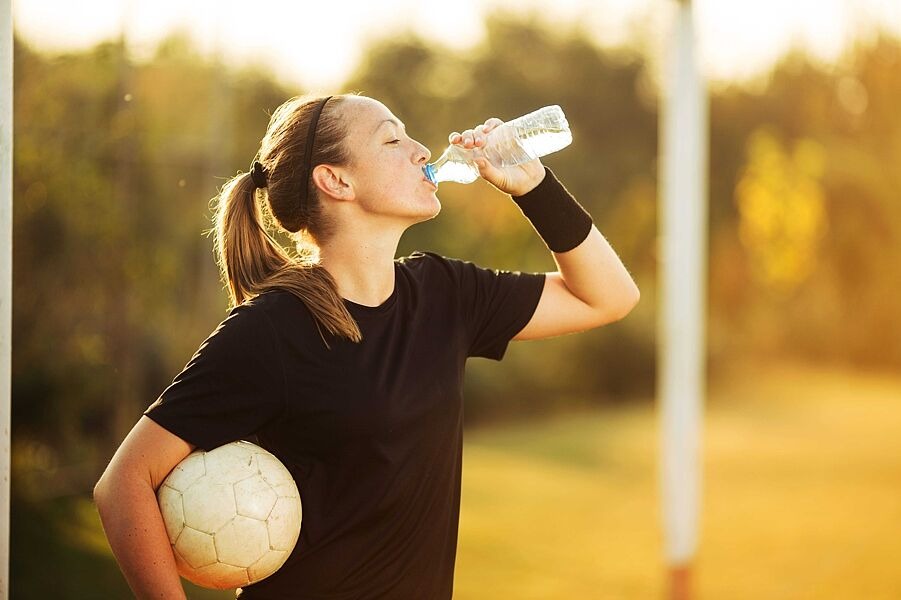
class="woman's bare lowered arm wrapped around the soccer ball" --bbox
[94,416,193,600]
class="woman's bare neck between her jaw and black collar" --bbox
[319,228,400,306]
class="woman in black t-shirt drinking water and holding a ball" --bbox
[94,95,638,600]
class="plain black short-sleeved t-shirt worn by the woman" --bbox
[145,252,544,600]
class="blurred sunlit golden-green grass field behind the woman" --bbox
[11,358,901,600]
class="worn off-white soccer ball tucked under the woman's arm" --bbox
[157,441,301,590]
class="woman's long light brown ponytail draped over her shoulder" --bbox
[215,173,363,346]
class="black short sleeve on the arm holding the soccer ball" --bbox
[144,304,285,450]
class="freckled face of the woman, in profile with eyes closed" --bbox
[342,96,441,222]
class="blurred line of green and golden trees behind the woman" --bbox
[13,15,901,494]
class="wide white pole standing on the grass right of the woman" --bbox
[658,0,707,600]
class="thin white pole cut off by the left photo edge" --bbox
[0,0,13,600]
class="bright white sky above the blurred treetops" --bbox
[13,0,901,91]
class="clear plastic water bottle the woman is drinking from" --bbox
[422,104,573,184]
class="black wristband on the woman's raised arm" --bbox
[512,167,593,252]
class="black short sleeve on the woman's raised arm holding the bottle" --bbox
[448,254,545,360]
